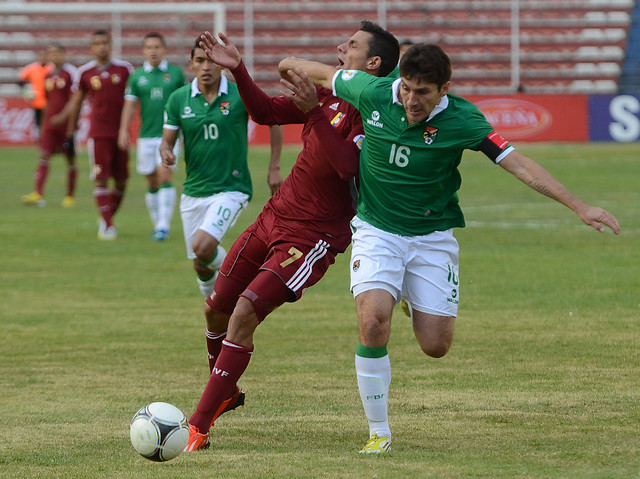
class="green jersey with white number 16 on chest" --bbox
[334,70,510,236]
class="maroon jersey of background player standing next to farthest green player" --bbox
[74,59,133,138]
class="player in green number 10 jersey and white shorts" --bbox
[160,37,282,298]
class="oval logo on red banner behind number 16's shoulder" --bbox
[476,98,553,140]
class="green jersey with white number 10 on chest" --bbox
[164,76,253,198]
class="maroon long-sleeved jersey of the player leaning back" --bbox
[233,64,364,252]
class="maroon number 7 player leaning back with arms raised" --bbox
[185,22,398,451]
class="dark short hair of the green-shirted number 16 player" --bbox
[400,43,451,90]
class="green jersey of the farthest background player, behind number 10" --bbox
[124,60,185,138]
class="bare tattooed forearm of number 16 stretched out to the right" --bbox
[499,151,620,234]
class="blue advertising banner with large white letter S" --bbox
[589,94,640,143]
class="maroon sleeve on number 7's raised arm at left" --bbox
[231,61,306,125]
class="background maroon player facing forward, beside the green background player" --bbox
[54,30,133,240]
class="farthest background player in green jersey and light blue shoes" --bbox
[118,32,185,241]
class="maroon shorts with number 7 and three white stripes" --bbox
[209,211,337,321]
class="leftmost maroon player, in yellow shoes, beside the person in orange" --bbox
[22,43,78,208]
